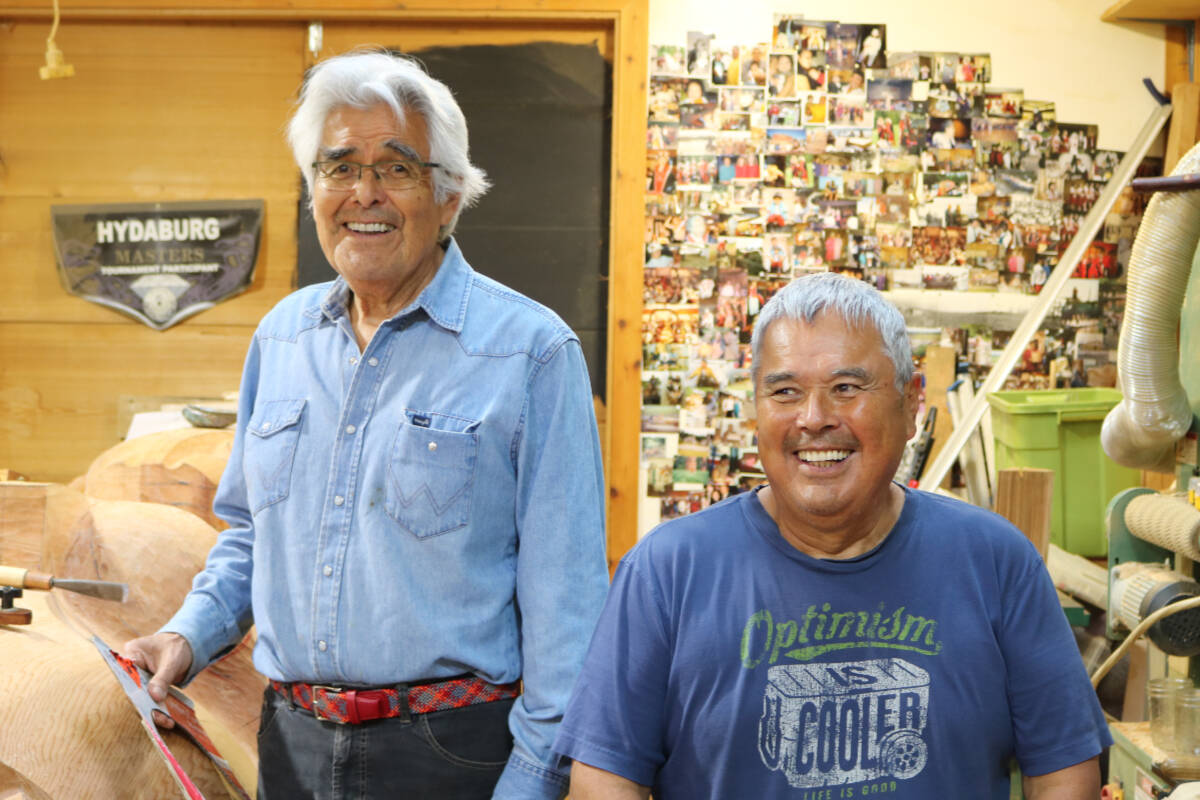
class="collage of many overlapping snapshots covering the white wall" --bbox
[642,16,1160,527]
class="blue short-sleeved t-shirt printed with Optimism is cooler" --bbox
[554,491,1112,800]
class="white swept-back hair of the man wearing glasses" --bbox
[287,50,490,239]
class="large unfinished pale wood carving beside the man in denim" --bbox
[0,429,264,800]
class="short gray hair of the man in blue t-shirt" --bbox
[750,272,913,395]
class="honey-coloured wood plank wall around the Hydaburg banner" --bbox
[0,20,306,482]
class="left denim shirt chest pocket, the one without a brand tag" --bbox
[242,399,305,513]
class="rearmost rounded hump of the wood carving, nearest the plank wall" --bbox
[84,428,233,530]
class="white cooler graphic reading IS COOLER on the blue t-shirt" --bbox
[758,658,929,788]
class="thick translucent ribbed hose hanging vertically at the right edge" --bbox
[1100,145,1200,473]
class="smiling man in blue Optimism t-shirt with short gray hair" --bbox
[554,273,1112,800]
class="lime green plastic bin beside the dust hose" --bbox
[988,389,1141,555]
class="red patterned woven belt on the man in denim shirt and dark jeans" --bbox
[271,676,521,724]
